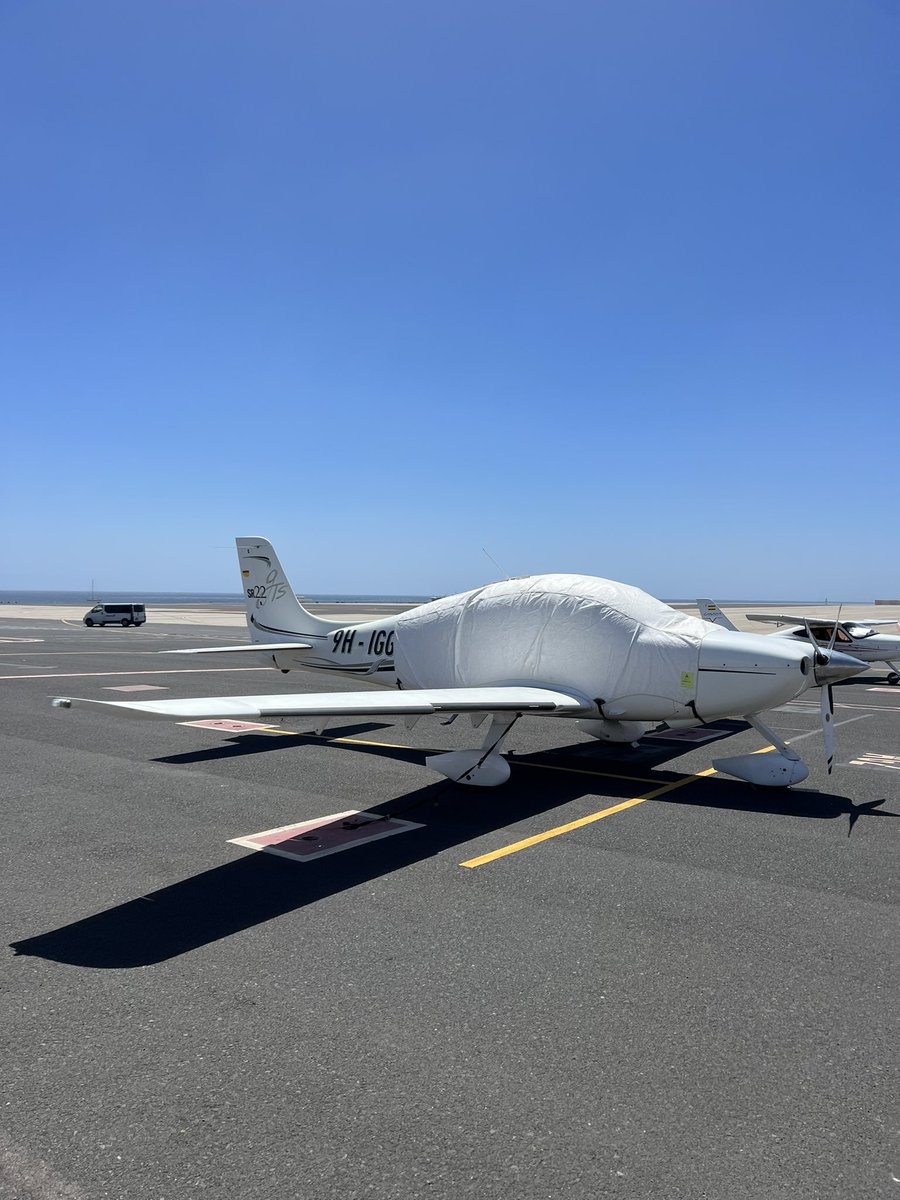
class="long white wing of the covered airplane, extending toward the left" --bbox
[53,685,596,721]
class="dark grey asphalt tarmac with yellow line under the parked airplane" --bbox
[0,611,900,1200]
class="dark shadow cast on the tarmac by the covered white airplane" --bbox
[12,722,895,970]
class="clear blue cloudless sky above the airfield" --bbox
[0,0,900,599]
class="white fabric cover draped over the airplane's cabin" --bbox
[395,575,715,715]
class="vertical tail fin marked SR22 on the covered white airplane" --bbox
[234,538,343,642]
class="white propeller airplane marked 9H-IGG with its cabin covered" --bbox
[53,538,864,787]
